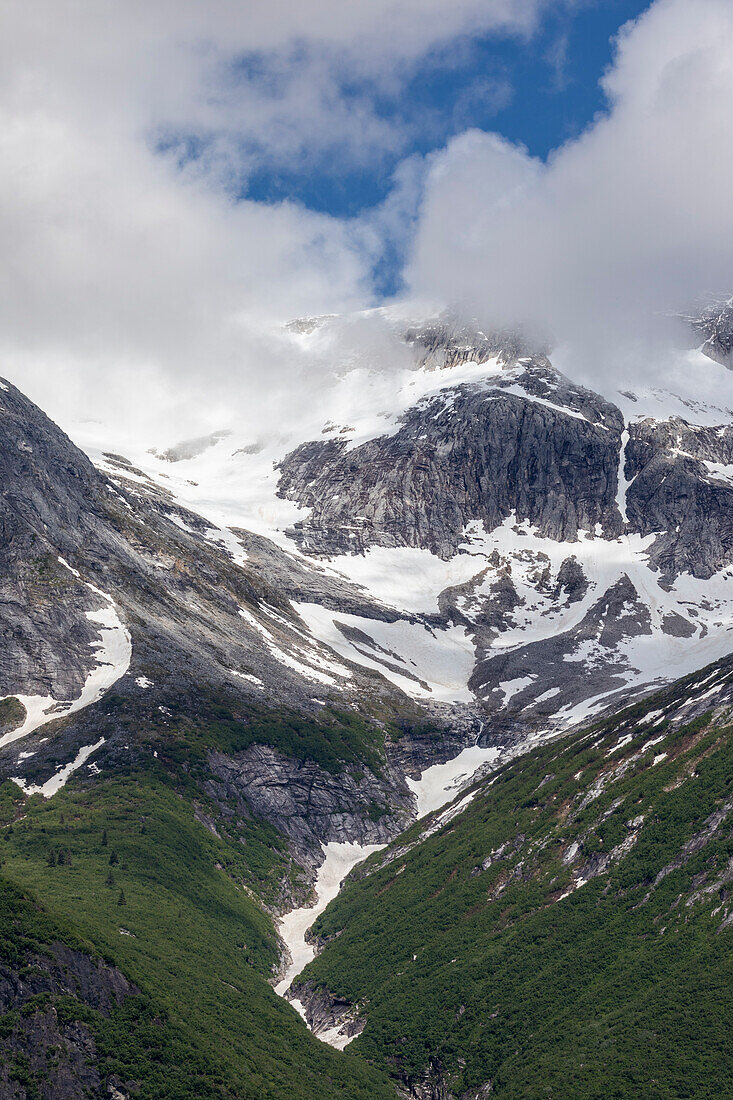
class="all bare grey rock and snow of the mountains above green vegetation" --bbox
[0,301,733,862]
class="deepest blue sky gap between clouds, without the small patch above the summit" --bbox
[245,0,648,218]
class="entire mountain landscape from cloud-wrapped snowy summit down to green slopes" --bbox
[0,312,733,1100]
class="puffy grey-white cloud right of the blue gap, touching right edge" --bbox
[409,0,733,375]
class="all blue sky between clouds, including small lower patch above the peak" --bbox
[230,0,648,300]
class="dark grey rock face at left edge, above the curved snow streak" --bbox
[0,386,124,699]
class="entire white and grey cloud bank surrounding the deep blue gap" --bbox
[0,0,733,438]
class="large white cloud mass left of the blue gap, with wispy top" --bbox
[0,0,546,437]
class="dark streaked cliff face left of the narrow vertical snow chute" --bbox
[280,360,623,559]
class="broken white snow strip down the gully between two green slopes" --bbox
[270,745,501,1049]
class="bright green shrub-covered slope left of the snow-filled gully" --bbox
[0,762,394,1100]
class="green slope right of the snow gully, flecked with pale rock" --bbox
[302,666,733,1100]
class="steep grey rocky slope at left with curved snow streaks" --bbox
[0,376,451,868]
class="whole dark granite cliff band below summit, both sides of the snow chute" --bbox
[280,360,733,578]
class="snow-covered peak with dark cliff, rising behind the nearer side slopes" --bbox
[59,310,733,748]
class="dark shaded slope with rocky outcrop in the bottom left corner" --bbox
[0,876,230,1098]
